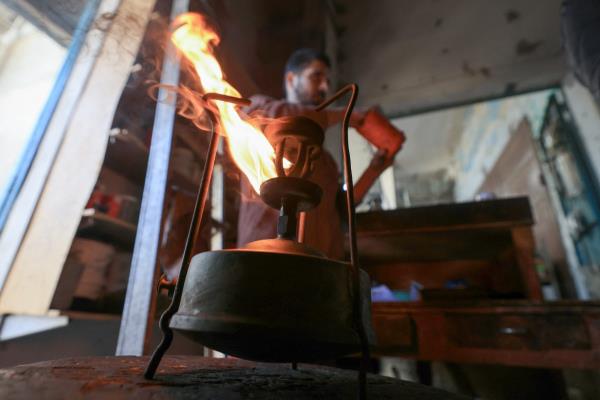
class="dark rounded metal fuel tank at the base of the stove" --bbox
[171,250,374,362]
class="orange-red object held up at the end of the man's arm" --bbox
[356,108,406,159]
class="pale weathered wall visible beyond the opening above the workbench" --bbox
[378,90,556,206]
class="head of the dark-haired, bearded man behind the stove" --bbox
[284,49,331,106]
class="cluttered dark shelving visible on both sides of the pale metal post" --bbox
[53,126,206,314]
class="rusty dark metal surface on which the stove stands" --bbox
[0,356,466,400]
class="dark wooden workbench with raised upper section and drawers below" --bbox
[357,197,600,368]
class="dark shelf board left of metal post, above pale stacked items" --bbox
[77,208,136,248]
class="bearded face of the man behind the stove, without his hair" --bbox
[286,60,329,106]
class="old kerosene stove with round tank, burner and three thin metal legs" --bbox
[145,85,374,398]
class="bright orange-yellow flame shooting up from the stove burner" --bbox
[171,13,277,193]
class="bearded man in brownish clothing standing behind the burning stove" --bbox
[238,49,404,259]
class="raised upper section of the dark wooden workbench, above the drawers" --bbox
[356,197,542,300]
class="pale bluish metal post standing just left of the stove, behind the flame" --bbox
[116,0,189,356]
